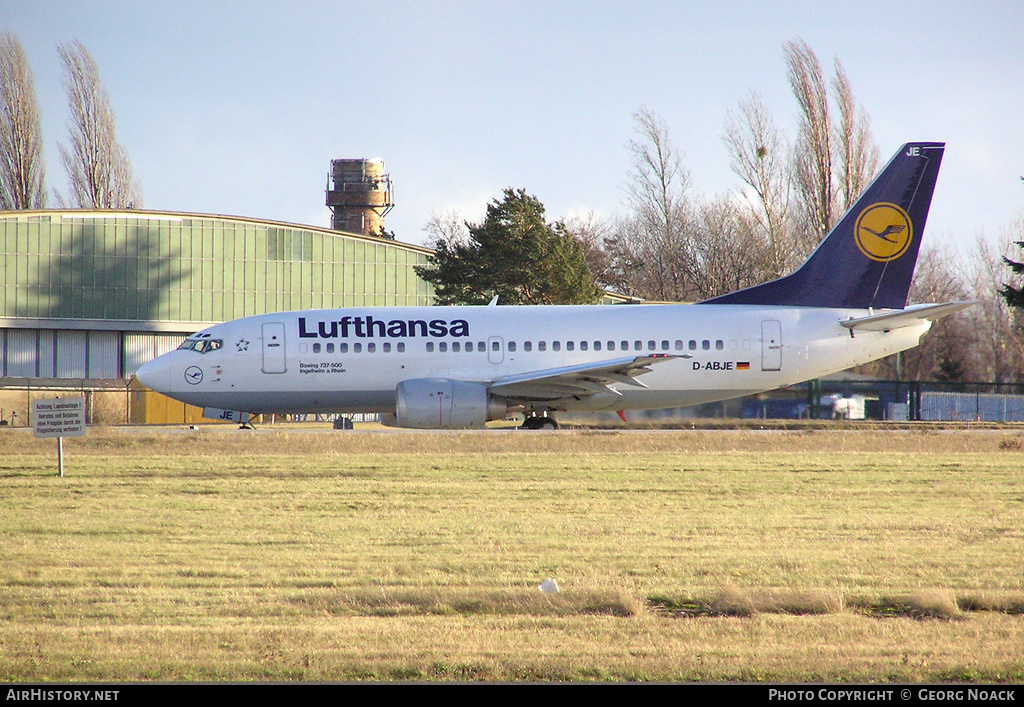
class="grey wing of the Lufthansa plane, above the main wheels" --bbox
[489,354,679,402]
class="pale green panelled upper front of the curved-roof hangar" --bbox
[0,210,433,332]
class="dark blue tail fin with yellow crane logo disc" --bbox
[703,142,945,309]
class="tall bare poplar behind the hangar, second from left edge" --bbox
[57,40,142,209]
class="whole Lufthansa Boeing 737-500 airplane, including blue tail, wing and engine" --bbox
[137,142,972,428]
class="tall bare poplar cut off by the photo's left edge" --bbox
[0,32,46,210]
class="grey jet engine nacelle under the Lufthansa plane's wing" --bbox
[381,378,508,429]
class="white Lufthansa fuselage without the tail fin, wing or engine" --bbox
[138,304,930,413]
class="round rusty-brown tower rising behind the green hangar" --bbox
[327,160,394,236]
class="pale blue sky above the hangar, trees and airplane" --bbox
[0,0,1024,243]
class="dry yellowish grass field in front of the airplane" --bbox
[0,428,1024,681]
